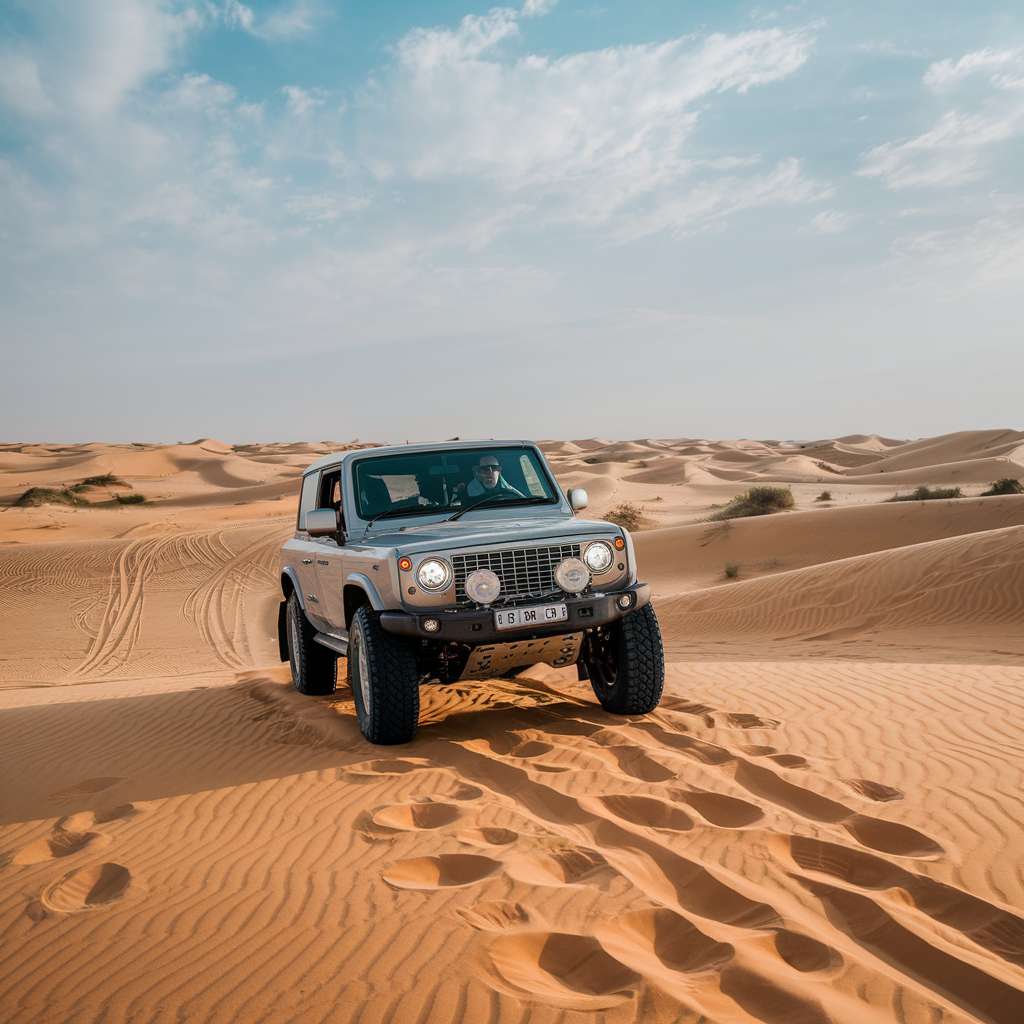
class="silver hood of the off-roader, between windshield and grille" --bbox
[357,515,620,554]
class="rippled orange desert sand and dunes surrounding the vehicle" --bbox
[0,430,1024,1024]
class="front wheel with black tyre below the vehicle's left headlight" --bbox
[348,605,420,743]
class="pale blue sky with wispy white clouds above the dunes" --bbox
[0,0,1024,440]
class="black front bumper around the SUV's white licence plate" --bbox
[380,583,650,644]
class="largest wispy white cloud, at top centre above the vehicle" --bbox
[370,24,812,232]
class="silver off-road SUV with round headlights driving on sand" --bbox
[278,441,665,743]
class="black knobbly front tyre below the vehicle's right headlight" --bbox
[583,604,665,715]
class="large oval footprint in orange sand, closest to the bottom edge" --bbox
[488,932,641,1010]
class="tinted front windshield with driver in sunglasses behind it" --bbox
[354,447,560,519]
